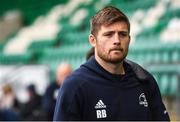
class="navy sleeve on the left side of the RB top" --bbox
[53,78,81,121]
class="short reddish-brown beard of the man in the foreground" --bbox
[97,47,128,64]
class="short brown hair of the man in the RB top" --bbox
[90,6,130,36]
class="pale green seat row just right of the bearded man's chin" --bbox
[128,43,180,65]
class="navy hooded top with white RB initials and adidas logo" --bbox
[54,57,169,121]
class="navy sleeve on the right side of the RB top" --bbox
[149,76,170,121]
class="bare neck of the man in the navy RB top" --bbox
[95,55,125,75]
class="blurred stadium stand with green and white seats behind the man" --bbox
[0,0,180,120]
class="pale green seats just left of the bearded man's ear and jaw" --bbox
[37,43,90,72]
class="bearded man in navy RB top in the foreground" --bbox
[54,6,169,121]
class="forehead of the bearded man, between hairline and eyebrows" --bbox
[99,21,128,33]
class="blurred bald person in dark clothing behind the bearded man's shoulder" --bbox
[43,63,72,121]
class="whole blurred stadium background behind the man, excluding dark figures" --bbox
[0,0,180,120]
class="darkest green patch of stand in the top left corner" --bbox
[0,0,69,24]
